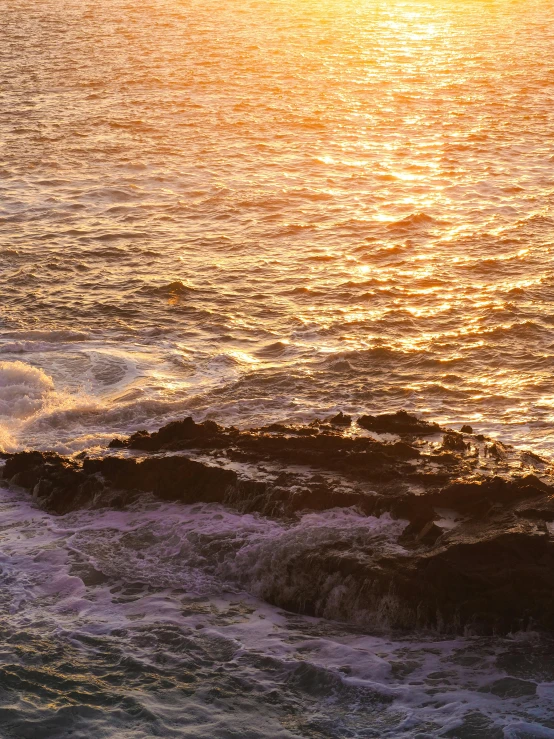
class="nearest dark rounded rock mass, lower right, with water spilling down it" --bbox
[262,531,554,634]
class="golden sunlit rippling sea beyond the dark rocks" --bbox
[0,0,554,448]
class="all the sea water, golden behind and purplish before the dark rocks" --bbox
[0,0,554,739]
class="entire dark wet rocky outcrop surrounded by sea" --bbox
[3,412,554,633]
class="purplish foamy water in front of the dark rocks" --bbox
[0,489,554,739]
